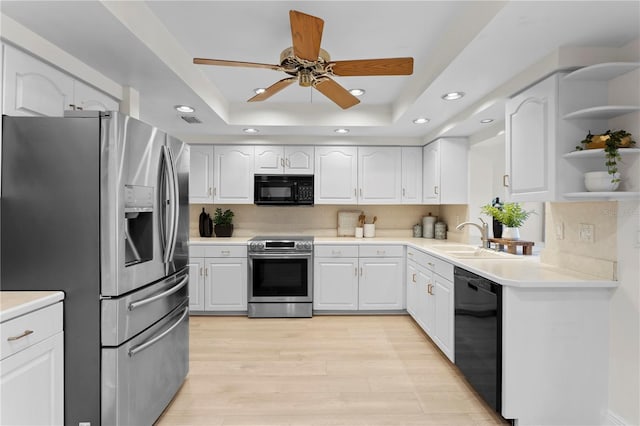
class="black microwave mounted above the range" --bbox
[253,175,313,206]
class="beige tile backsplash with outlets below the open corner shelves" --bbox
[541,201,618,279]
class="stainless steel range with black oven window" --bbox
[248,236,313,318]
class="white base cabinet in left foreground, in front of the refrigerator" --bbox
[0,302,63,425]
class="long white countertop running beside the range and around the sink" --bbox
[189,237,618,288]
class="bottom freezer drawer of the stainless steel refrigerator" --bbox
[101,301,189,426]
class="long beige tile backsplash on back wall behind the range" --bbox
[189,204,442,238]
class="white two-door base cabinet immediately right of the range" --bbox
[313,245,404,311]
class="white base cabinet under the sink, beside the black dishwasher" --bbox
[406,248,454,361]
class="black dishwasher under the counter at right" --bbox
[454,267,502,413]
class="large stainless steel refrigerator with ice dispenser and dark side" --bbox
[0,111,189,426]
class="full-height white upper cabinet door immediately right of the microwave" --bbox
[314,146,358,204]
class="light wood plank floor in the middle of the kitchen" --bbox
[157,315,504,426]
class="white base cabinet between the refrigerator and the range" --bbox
[189,245,247,312]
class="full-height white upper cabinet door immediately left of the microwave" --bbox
[213,145,253,204]
